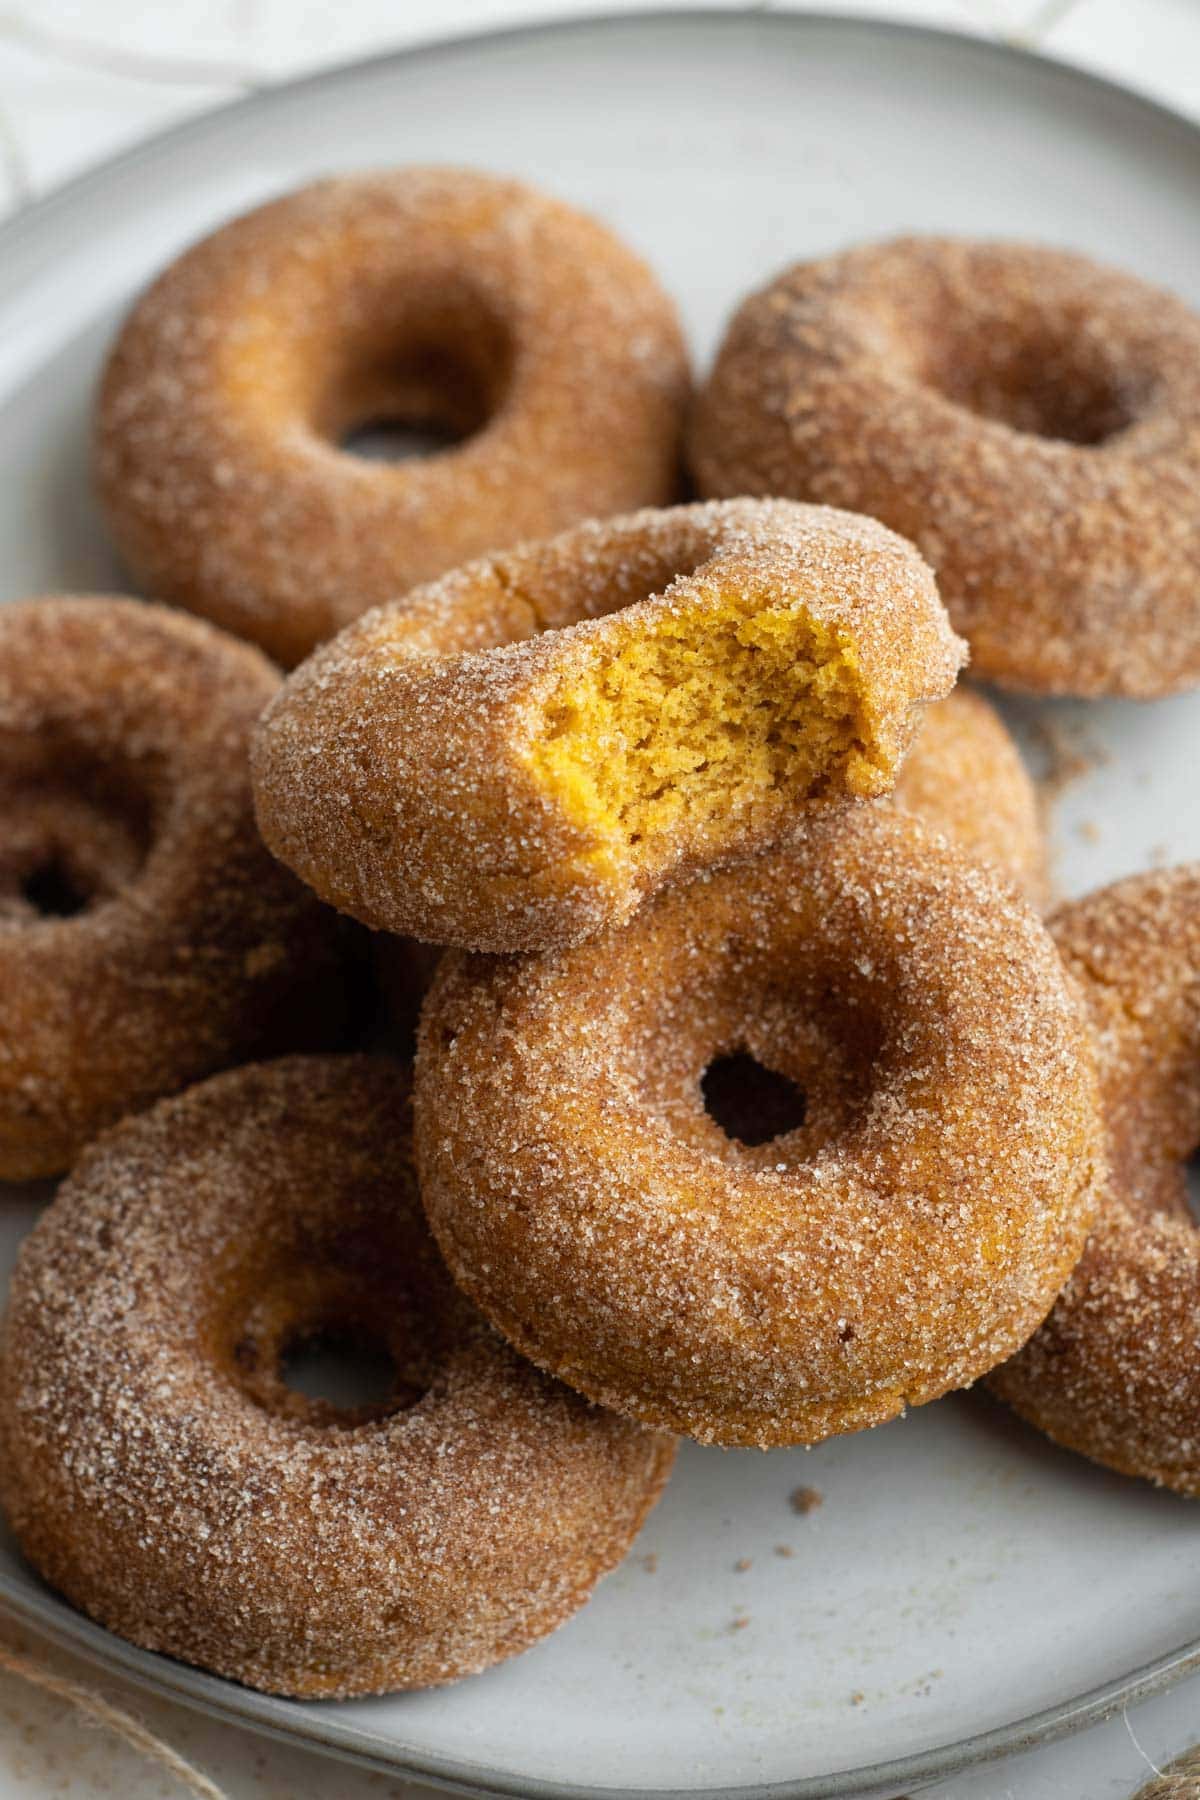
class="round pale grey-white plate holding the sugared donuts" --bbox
[0,14,1200,1800]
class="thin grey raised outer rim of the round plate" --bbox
[0,5,1200,1800]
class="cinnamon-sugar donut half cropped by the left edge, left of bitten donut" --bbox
[0,598,342,1181]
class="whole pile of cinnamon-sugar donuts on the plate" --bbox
[0,169,1200,1696]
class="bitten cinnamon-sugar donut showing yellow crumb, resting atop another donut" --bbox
[254,500,963,952]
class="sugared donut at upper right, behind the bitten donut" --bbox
[689,238,1200,698]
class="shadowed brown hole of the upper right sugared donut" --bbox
[921,329,1133,448]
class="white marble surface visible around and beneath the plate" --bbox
[0,0,1200,1800]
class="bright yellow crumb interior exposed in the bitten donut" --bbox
[533,594,877,844]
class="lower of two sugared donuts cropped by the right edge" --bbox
[991,862,1200,1496]
